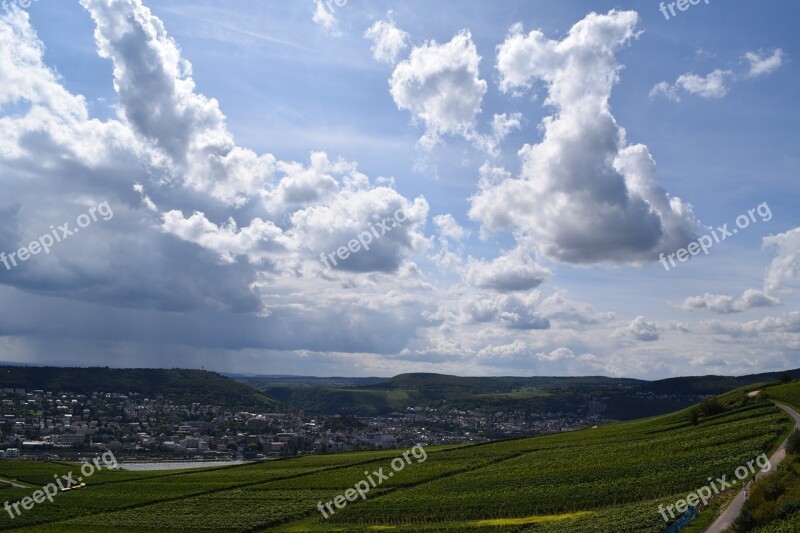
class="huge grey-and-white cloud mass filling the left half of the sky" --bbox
[0,0,438,362]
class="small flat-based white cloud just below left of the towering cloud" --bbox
[465,248,550,292]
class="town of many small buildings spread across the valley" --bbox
[0,388,604,460]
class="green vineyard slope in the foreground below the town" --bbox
[0,384,798,532]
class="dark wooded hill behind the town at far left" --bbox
[0,366,279,410]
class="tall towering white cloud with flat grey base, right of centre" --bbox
[470,10,695,264]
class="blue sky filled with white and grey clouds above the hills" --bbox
[0,0,800,379]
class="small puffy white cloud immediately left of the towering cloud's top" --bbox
[389,30,487,149]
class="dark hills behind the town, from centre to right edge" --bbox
[242,370,800,420]
